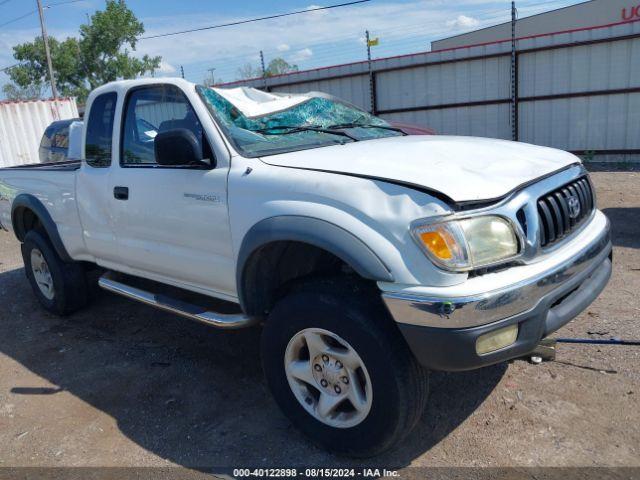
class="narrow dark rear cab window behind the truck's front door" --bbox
[85,92,118,167]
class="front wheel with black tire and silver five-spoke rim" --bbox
[261,280,428,457]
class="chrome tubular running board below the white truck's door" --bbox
[98,272,257,330]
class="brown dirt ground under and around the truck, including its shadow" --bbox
[0,167,640,469]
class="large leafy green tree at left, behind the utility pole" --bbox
[3,0,161,103]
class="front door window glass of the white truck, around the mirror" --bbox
[120,85,213,166]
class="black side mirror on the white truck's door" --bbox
[153,128,205,166]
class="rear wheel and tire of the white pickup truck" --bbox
[22,230,88,316]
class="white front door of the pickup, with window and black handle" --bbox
[111,84,235,298]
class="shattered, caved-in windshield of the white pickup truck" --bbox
[197,86,404,157]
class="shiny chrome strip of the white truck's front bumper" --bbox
[382,222,612,329]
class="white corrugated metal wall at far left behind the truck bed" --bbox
[0,98,78,167]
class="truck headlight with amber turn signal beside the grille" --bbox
[412,216,518,271]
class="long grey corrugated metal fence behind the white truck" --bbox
[223,21,640,161]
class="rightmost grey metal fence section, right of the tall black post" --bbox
[519,24,640,160]
